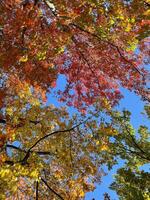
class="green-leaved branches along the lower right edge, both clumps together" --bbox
[106,105,150,200]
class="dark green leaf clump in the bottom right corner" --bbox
[110,168,150,200]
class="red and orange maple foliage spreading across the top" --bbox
[0,0,149,107]
